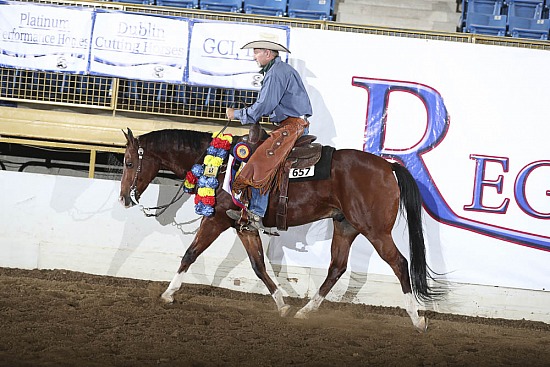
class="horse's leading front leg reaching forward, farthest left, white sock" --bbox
[160,216,231,303]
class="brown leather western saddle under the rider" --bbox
[234,124,323,231]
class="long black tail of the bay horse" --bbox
[392,163,444,301]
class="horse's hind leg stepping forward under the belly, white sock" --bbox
[294,219,359,319]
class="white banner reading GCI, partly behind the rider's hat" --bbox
[188,21,292,90]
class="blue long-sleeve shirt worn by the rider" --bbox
[235,56,313,125]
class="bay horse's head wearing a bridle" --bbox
[119,129,159,208]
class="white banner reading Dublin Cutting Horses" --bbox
[90,10,189,83]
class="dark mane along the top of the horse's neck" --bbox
[139,129,212,152]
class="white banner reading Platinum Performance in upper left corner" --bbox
[0,2,94,73]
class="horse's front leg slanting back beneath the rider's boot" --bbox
[238,231,296,317]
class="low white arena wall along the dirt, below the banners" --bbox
[0,171,550,322]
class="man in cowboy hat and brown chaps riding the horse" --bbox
[226,40,312,230]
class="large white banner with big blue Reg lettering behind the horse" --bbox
[280,29,550,291]
